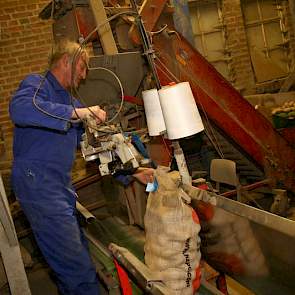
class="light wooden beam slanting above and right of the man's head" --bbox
[89,0,118,55]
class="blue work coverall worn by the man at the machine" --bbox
[10,72,99,295]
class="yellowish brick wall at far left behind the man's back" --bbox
[0,0,51,197]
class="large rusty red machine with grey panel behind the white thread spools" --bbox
[41,1,295,191]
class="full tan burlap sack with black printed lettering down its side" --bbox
[144,167,201,295]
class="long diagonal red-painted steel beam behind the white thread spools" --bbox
[153,33,295,191]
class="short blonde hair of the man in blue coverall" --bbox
[48,40,89,68]
